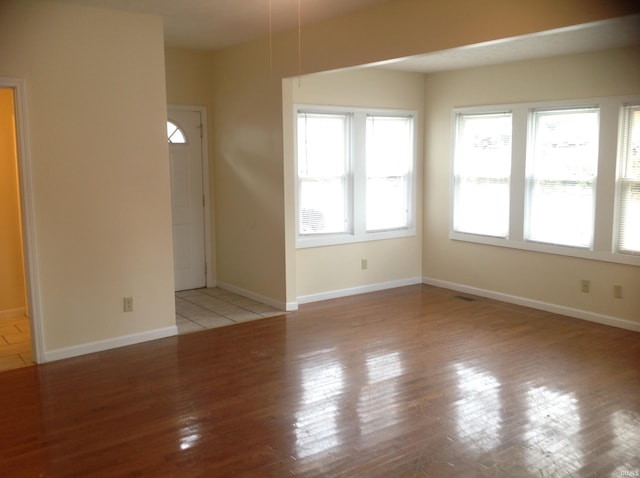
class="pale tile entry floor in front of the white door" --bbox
[176,287,284,334]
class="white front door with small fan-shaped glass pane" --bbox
[167,110,206,291]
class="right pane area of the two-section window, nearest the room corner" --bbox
[366,116,413,231]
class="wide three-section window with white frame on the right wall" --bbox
[449,96,640,265]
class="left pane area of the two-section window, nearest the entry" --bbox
[297,113,351,235]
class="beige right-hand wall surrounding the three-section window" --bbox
[423,48,640,322]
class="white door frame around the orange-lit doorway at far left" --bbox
[0,77,46,363]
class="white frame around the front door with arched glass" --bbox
[167,103,216,287]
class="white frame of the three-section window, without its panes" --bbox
[449,96,640,265]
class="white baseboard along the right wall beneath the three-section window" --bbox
[422,277,640,332]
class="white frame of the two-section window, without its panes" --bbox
[293,104,418,249]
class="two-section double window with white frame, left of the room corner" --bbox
[296,106,415,247]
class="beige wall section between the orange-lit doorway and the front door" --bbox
[0,0,175,355]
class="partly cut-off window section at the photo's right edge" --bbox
[616,105,640,254]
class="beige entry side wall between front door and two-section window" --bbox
[209,40,286,307]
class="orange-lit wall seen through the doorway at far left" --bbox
[0,88,25,317]
